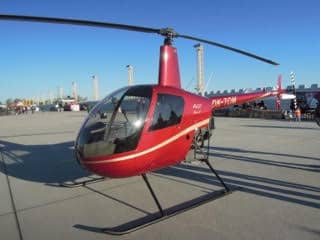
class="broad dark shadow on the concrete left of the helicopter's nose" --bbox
[0,140,91,186]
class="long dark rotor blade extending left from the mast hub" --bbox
[0,14,160,34]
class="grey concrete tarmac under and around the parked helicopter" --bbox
[0,112,320,240]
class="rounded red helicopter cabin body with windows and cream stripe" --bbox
[76,85,212,178]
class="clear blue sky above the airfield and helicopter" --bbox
[0,0,320,102]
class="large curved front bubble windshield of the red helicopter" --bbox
[75,86,152,158]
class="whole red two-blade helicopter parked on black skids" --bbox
[0,15,283,234]
